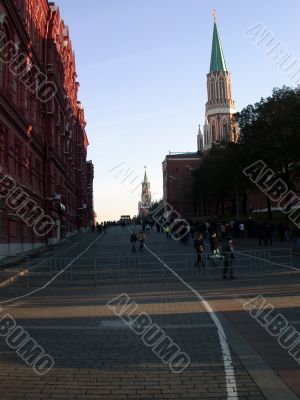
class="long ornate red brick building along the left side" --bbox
[0,0,93,254]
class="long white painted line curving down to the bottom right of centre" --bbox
[145,245,238,400]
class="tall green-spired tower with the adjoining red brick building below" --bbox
[163,11,238,218]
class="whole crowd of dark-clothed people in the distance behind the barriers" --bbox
[130,219,300,279]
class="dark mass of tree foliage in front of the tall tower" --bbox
[193,87,300,217]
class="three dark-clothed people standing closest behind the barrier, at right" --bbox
[194,232,235,279]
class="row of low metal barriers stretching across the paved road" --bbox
[18,249,294,287]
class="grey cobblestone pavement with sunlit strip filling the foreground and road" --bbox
[0,228,300,400]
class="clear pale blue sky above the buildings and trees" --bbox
[56,0,300,221]
